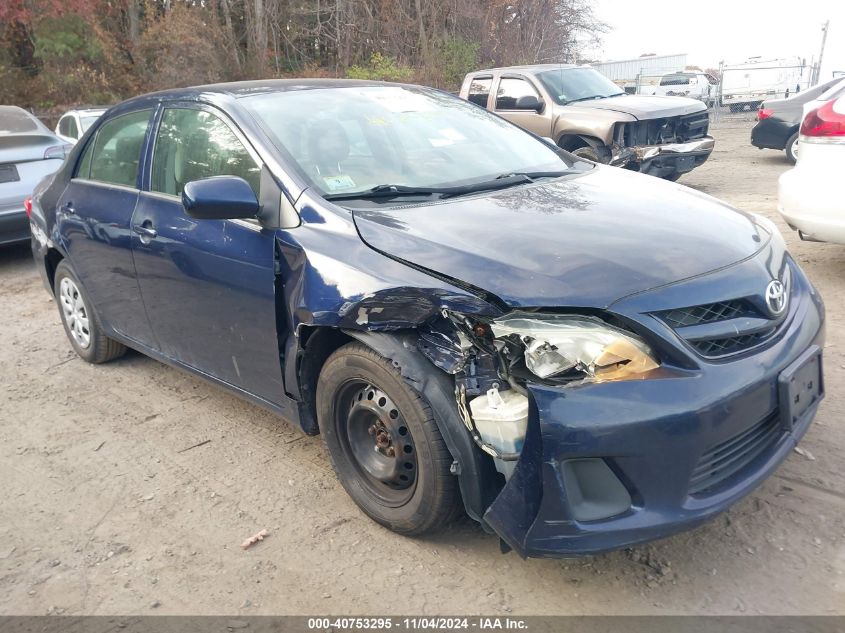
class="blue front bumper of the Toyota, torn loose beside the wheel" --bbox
[484,270,824,557]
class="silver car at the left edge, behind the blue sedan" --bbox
[0,106,73,244]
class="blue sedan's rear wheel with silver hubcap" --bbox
[53,260,126,364]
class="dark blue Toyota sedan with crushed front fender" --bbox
[30,80,824,556]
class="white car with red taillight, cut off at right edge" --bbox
[778,88,845,244]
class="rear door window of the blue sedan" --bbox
[76,110,151,187]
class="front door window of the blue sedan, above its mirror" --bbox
[150,108,261,196]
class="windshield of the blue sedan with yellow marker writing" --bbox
[242,86,571,198]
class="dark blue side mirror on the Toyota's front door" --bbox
[182,176,259,220]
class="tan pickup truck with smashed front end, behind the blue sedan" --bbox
[460,64,714,180]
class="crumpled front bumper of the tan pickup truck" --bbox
[610,136,716,178]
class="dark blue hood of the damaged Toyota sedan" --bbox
[353,166,771,308]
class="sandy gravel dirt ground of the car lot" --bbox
[0,120,845,615]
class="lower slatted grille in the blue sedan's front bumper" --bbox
[689,409,783,495]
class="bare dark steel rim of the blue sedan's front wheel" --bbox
[335,381,417,507]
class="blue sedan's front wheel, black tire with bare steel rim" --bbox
[316,342,460,535]
